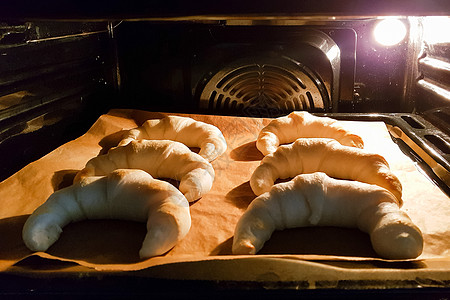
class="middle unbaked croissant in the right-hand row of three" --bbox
[250,138,402,201]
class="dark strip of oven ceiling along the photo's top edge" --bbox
[0,0,449,20]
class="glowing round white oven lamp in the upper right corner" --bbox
[373,18,406,46]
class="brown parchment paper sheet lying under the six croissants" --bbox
[0,110,450,271]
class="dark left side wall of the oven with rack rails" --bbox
[0,22,116,180]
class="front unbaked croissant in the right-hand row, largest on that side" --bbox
[232,173,423,259]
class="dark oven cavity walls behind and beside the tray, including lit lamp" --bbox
[0,16,450,194]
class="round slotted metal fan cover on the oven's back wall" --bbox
[200,58,330,117]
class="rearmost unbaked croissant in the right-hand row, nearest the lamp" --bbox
[256,111,364,155]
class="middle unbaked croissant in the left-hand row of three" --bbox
[75,140,215,202]
